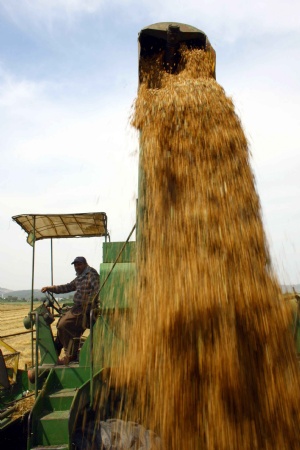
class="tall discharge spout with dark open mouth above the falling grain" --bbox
[137,22,216,253]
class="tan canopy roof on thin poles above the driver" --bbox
[13,212,108,244]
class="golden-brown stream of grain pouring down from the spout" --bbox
[112,49,300,450]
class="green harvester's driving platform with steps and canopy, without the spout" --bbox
[0,212,135,449]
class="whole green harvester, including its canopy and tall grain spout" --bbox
[0,22,300,450]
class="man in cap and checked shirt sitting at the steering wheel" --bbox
[41,256,100,365]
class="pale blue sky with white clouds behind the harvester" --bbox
[0,0,300,290]
